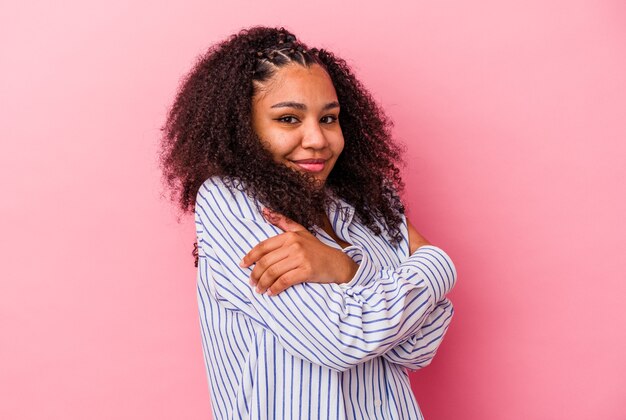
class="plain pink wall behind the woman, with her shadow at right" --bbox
[0,0,626,420]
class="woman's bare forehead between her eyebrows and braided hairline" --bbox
[253,63,337,106]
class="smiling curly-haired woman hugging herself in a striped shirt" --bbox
[162,27,456,419]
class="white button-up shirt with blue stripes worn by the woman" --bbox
[195,177,456,419]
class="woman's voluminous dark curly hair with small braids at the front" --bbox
[160,27,405,266]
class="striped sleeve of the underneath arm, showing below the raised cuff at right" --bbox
[383,299,454,371]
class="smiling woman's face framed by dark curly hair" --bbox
[252,63,344,183]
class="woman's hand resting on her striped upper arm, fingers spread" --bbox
[240,209,358,295]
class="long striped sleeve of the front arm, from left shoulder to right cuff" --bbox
[196,178,456,371]
